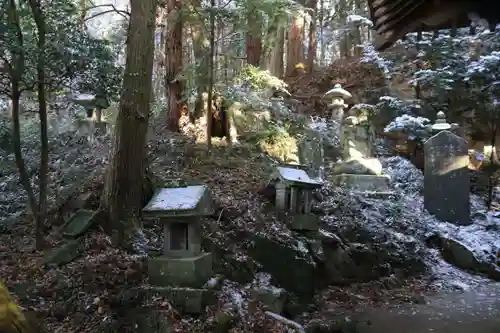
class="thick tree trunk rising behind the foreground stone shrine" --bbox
[102,0,157,246]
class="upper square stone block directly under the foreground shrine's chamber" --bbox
[148,253,213,288]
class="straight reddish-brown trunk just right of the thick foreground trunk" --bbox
[165,0,183,132]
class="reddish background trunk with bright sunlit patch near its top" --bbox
[286,11,304,75]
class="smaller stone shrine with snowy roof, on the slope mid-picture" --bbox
[271,166,323,230]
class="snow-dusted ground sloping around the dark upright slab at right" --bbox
[316,156,500,289]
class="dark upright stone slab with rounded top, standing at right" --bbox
[424,131,472,225]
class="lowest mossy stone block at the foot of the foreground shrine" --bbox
[149,287,215,314]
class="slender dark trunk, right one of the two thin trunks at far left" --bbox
[29,0,49,250]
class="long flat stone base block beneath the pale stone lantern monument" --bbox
[329,174,391,192]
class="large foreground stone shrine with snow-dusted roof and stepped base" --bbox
[142,186,214,313]
